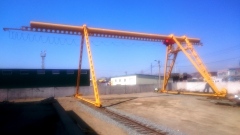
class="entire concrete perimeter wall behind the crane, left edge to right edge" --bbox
[0,82,240,101]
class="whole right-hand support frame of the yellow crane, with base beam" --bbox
[161,35,227,97]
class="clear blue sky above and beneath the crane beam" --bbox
[0,0,240,77]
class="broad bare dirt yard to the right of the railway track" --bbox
[97,93,240,135]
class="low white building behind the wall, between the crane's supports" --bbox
[111,74,159,85]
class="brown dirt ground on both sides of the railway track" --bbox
[3,93,240,135]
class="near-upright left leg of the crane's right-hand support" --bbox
[161,45,178,92]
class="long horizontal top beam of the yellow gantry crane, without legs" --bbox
[4,21,201,45]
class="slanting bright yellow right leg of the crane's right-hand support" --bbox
[171,35,227,97]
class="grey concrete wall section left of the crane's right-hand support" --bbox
[0,85,155,101]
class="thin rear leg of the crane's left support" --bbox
[75,33,84,96]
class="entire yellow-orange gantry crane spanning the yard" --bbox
[3,22,227,107]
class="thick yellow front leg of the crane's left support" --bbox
[83,25,101,107]
